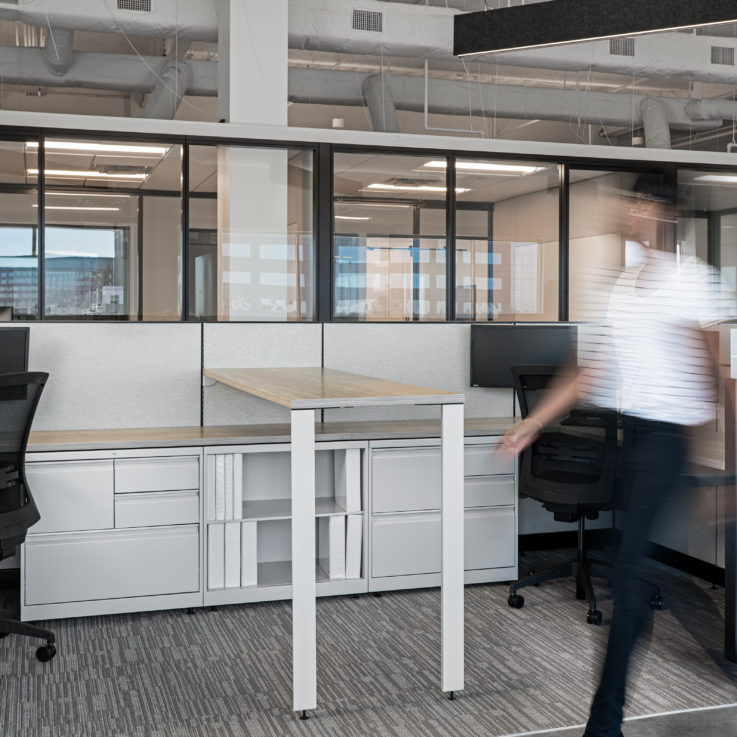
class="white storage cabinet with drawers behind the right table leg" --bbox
[369,437,517,591]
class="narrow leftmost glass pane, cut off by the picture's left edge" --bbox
[0,141,38,320]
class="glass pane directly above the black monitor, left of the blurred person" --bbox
[454,159,559,321]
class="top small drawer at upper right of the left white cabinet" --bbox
[115,456,200,494]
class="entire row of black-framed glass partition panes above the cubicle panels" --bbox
[0,131,737,322]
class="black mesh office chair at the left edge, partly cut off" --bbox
[0,373,56,662]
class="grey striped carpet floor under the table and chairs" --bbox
[0,563,737,737]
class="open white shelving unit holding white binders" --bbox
[204,442,368,604]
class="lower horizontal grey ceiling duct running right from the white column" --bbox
[289,69,724,130]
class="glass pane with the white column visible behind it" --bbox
[187,146,315,321]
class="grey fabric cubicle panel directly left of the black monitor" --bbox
[324,323,513,420]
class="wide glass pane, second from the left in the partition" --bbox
[44,139,182,320]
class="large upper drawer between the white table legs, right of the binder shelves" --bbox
[371,447,441,512]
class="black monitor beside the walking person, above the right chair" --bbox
[471,325,577,388]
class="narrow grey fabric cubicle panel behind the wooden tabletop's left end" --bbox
[203,323,322,425]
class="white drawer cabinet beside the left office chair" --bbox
[21,448,202,620]
